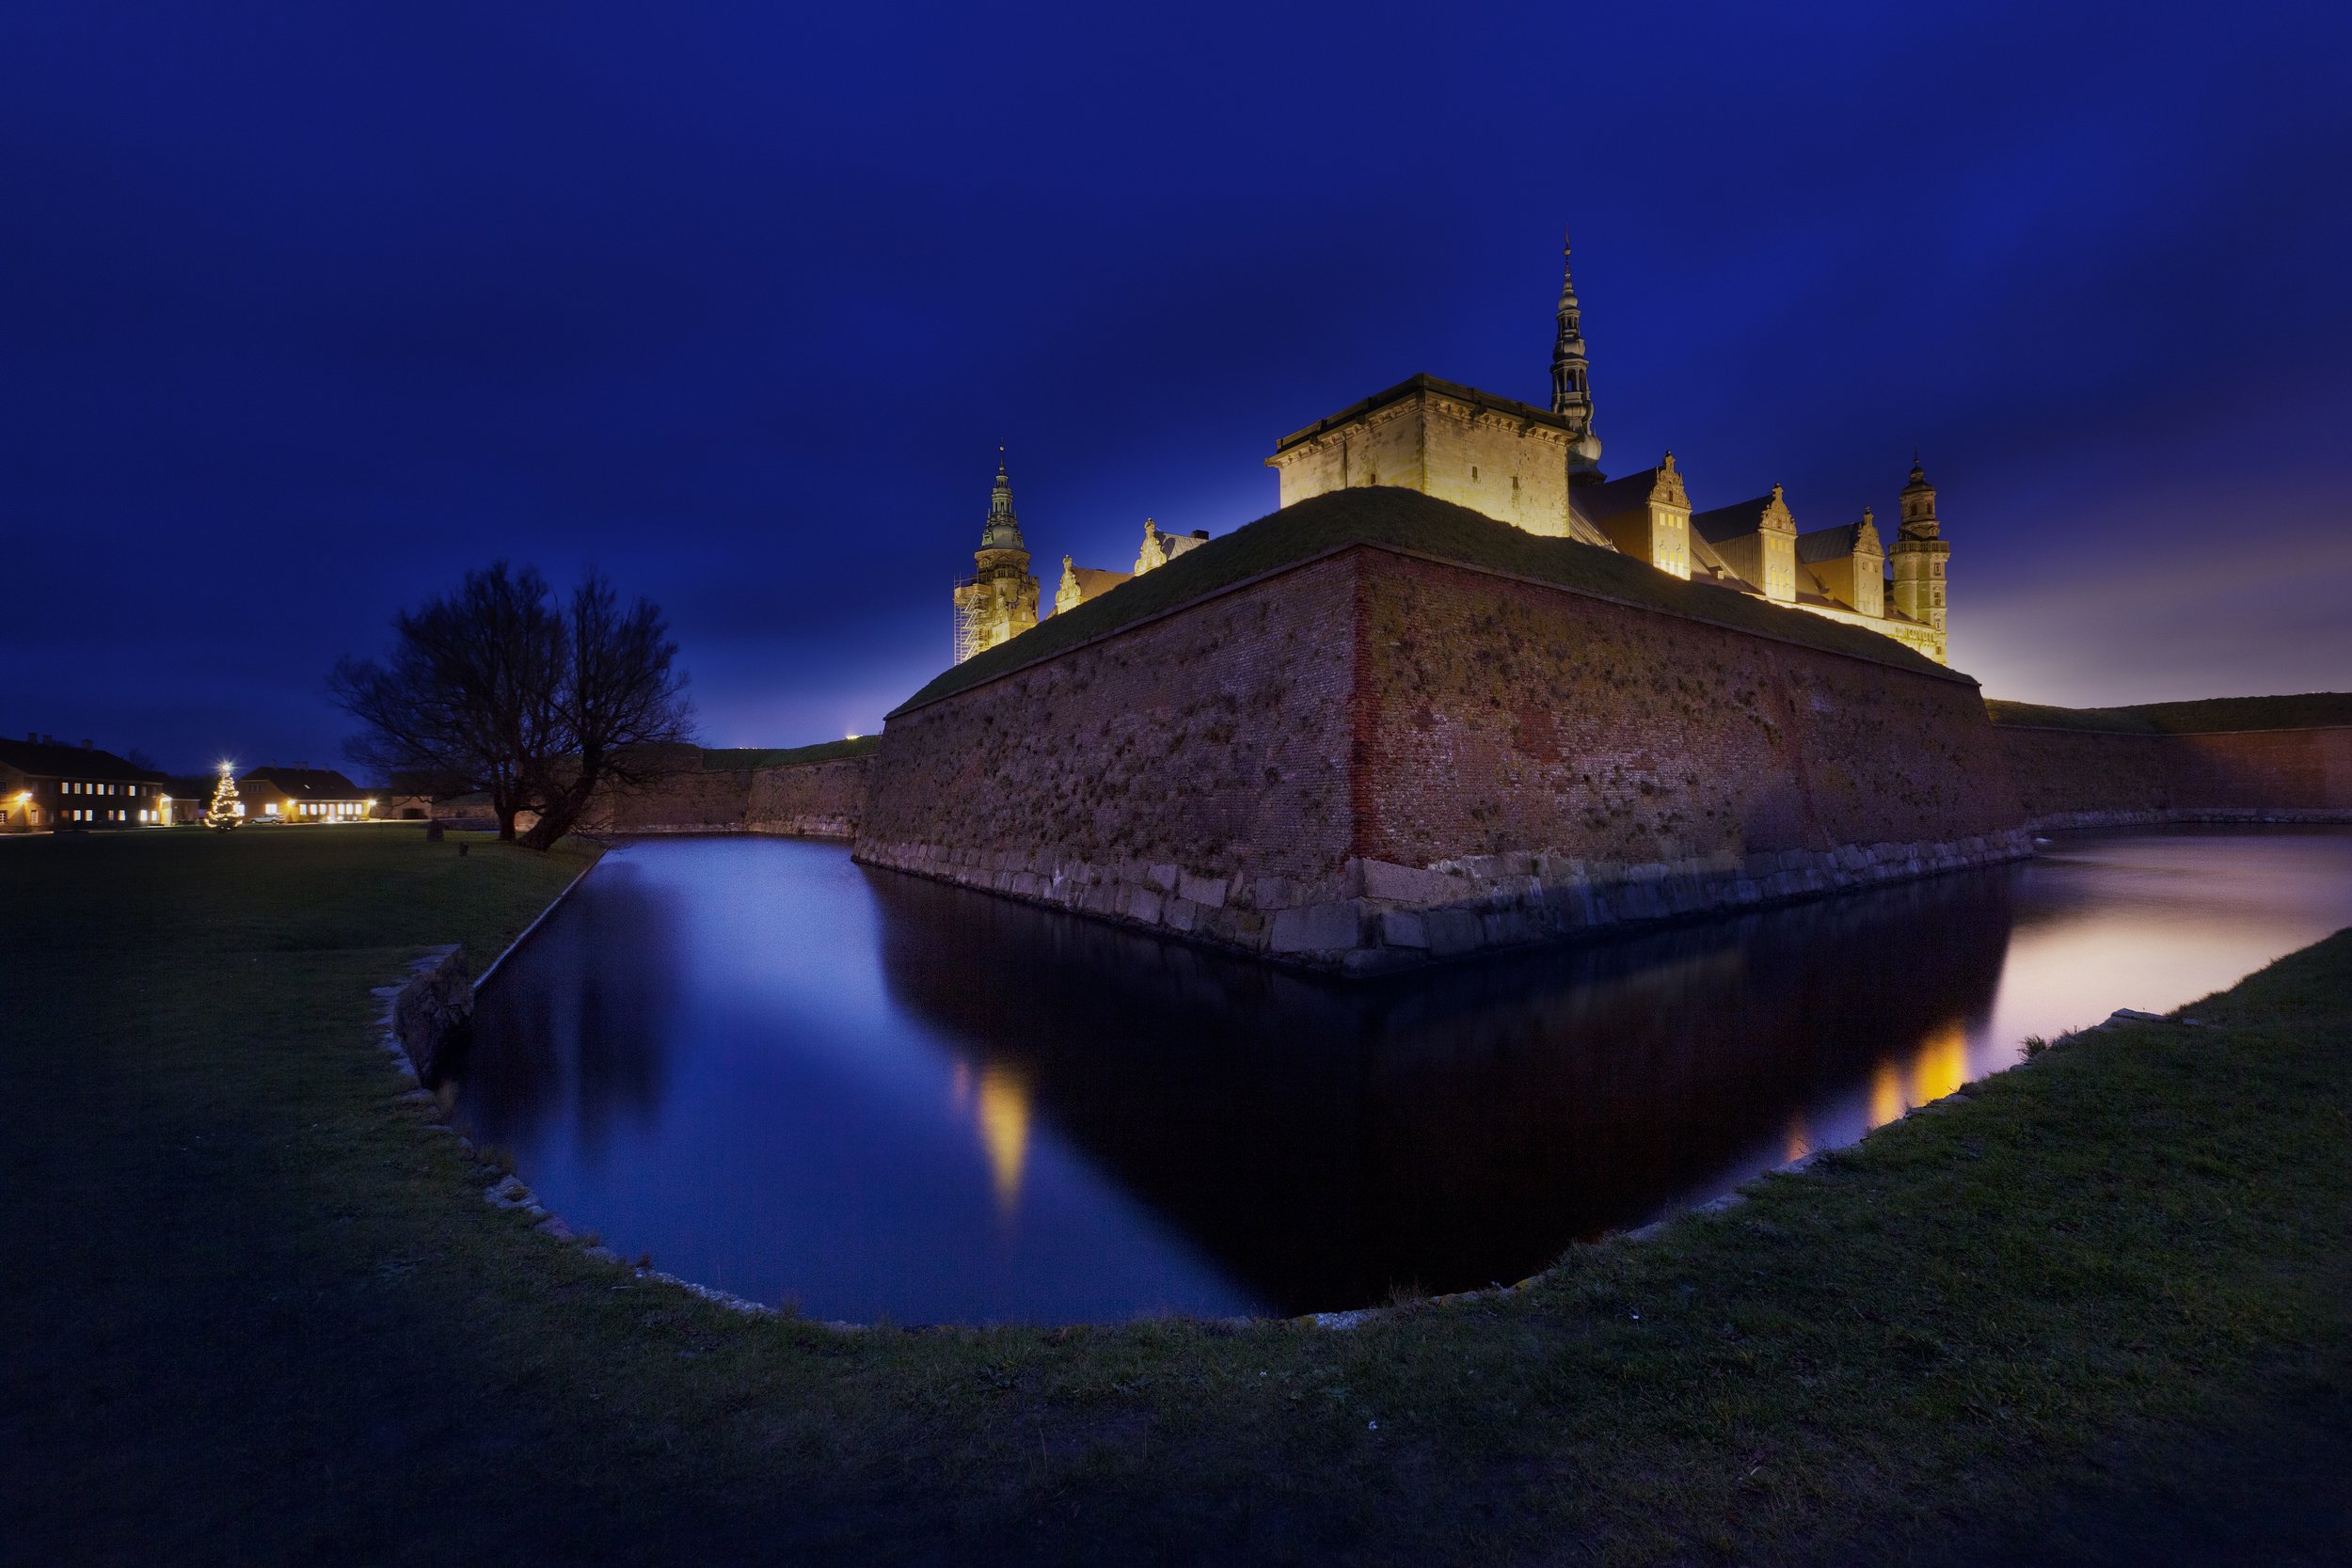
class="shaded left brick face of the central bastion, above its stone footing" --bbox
[859,552,1362,879]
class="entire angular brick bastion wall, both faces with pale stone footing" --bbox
[856,547,2026,974]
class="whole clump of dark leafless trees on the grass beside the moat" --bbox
[327,562,691,848]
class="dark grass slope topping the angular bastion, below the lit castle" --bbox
[894,484,1969,715]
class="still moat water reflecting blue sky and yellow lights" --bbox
[454,830,2352,1323]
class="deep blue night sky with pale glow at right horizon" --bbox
[0,2,2352,767]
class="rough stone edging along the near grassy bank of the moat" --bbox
[374,907,2201,1333]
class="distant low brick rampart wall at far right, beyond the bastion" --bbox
[1994,724,2352,828]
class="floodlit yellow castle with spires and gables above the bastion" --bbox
[955,230,1952,663]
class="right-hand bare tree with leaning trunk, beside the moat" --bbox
[522,571,694,848]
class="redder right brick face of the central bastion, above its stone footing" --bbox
[1358,552,2018,865]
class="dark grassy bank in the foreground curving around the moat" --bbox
[0,828,2352,1563]
